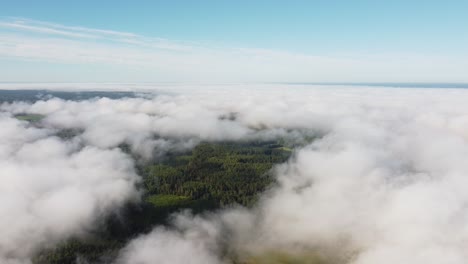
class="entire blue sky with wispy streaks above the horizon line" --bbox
[0,0,468,82]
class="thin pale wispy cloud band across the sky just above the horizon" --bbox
[0,18,468,82]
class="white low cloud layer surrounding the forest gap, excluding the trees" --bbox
[0,85,468,264]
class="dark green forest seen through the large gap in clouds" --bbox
[34,141,291,264]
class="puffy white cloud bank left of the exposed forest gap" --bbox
[0,114,139,263]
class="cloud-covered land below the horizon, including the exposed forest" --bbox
[0,85,468,264]
